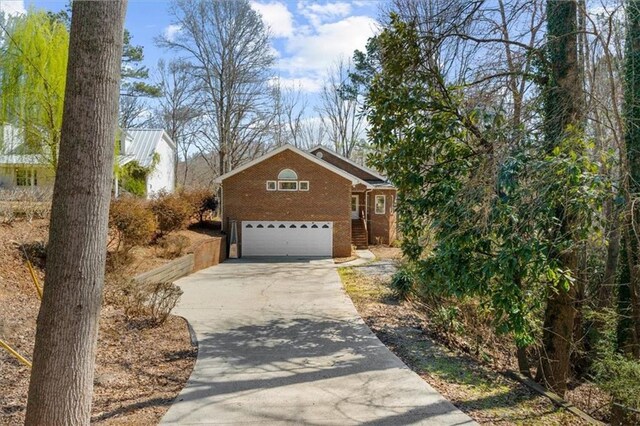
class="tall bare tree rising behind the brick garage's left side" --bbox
[158,0,274,174]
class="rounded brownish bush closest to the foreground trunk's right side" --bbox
[109,198,156,253]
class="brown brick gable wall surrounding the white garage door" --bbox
[222,150,351,257]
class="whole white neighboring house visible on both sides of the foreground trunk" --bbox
[0,126,176,198]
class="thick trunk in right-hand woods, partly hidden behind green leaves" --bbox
[537,0,583,396]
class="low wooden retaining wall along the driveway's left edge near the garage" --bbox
[133,236,227,283]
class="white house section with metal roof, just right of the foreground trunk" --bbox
[115,129,176,198]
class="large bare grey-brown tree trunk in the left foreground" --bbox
[26,0,126,425]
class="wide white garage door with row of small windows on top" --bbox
[242,221,333,256]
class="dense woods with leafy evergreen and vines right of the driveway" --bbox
[351,0,640,420]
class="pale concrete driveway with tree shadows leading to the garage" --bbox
[162,260,473,425]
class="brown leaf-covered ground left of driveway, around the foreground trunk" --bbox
[0,220,196,425]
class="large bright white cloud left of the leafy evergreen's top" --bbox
[279,16,376,77]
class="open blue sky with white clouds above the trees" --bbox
[0,0,382,98]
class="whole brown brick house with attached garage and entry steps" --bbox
[216,145,396,257]
